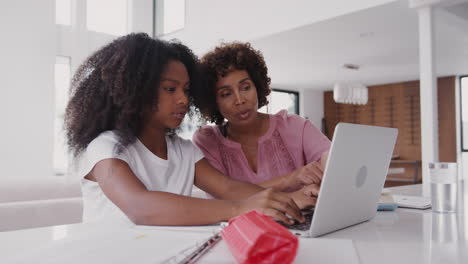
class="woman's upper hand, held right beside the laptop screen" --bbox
[287,161,323,190]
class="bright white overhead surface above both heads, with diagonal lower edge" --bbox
[163,0,396,56]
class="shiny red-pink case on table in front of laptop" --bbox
[221,211,299,264]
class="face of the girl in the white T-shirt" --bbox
[151,60,190,129]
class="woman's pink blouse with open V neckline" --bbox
[193,110,330,183]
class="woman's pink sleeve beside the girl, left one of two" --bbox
[192,127,226,175]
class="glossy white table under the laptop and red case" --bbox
[0,185,468,264]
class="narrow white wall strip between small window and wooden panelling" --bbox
[299,89,323,129]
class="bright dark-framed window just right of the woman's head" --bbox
[259,89,299,115]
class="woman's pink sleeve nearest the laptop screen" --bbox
[302,120,331,164]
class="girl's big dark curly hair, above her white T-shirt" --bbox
[65,33,198,156]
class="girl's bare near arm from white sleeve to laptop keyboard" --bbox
[87,159,303,225]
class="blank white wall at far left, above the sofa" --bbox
[0,0,55,179]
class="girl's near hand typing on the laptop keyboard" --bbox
[234,189,304,224]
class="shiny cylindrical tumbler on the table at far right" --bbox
[429,162,457,213]
